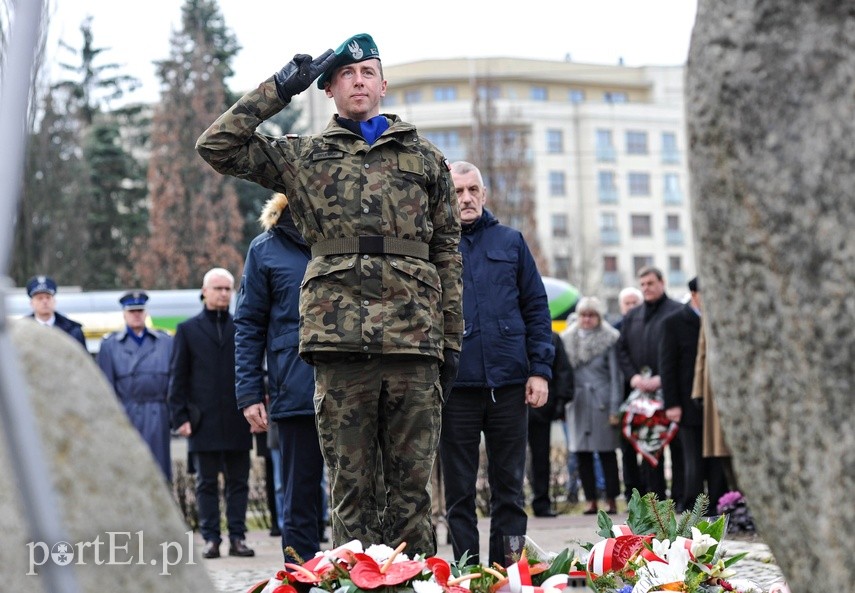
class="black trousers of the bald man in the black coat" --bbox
[198,449,254,544]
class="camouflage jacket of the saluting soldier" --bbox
[196,78,463,362]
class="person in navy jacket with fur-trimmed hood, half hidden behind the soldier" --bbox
[235,193,324,562]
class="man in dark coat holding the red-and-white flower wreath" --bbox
[617,266,683,510]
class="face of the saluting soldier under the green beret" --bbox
[325,59,386,121]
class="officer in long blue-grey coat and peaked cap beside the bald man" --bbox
[98,290,172,481]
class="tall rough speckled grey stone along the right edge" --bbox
[686,0,855,593]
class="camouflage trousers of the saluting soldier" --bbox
[315,354,442,555]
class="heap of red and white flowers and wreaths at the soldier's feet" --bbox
[247,490,762,593]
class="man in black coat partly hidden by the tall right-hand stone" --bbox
[659,278,725,509]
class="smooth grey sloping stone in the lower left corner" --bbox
[0,320,214,593]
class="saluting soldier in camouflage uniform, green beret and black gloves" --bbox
[197,33,463,554]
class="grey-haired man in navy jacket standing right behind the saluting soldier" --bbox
[440,161,555,566]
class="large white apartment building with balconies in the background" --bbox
[303,58,695,313]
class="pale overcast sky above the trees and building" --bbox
[50,0,696,101]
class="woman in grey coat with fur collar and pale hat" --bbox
[561,297,623,515]
